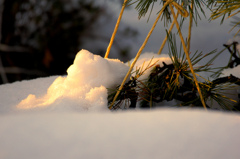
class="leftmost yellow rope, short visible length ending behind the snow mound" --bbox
[104,0,128,58]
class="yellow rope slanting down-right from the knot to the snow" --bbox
[169,5,207,110]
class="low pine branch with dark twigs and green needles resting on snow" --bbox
[109,33,240,111]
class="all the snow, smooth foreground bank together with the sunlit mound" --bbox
[0,50,240,159]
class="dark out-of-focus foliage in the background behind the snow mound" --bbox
[0,0,137,84]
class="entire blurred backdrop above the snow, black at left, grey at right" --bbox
[0,0,238,84]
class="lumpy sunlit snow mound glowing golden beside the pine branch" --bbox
[17,50,129,110]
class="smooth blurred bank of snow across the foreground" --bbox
[0,109,240,159]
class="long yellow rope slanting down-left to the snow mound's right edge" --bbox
[109,0,173,109]
